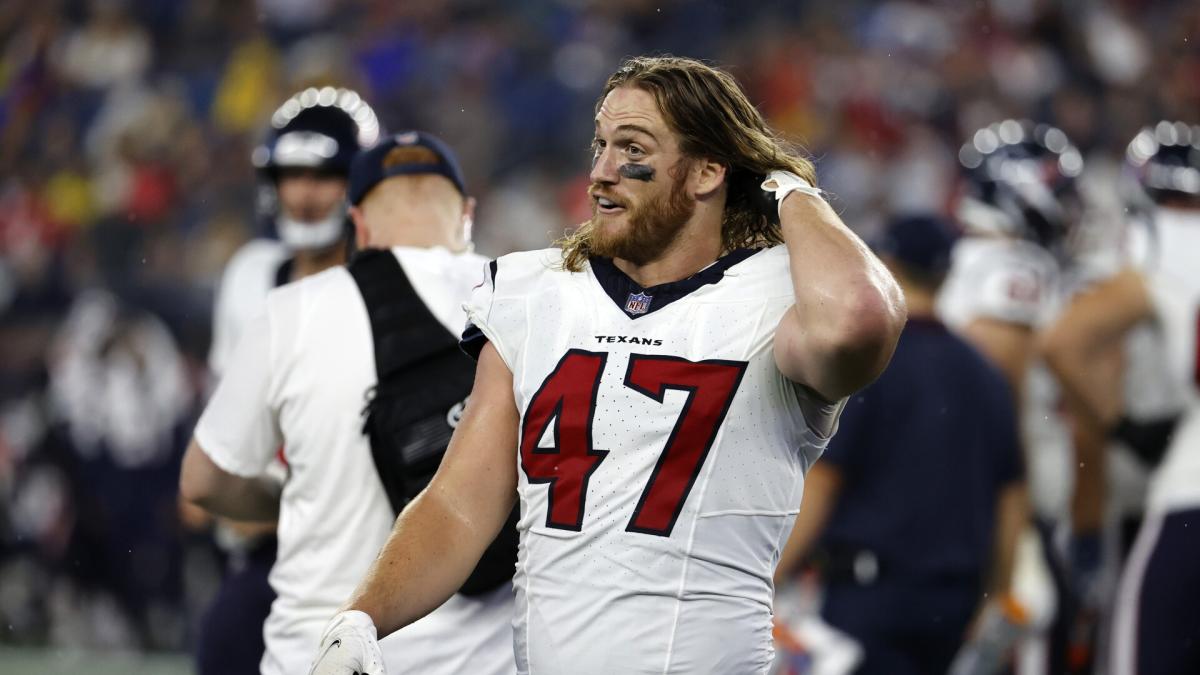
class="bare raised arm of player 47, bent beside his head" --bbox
[764,174,907,401]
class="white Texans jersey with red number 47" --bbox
[464,246,840,675]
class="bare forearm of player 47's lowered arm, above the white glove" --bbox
[346,484,512,639]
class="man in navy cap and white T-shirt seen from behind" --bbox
[180,127,514,675]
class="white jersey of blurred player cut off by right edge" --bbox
[1144,209,1200,512]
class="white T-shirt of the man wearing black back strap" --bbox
[196,247,514,675]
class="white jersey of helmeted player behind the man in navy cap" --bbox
[209,239,290,377]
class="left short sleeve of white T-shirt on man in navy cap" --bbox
[196,315,283,477]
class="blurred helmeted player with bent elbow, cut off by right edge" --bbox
[1045,121,1200,675]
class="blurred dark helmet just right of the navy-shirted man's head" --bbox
[958,120,1084,249]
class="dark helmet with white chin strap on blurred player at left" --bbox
[252,86,379,251]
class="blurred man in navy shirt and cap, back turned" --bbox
[775,215,1026,675]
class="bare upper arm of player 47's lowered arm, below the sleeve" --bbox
[427,342,520,536]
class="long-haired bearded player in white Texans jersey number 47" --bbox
[313,56,905,675]
